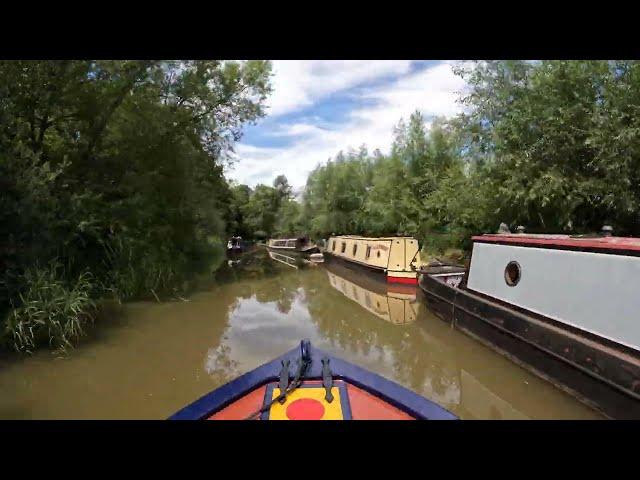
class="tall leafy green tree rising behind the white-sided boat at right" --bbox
[452,61,640,233]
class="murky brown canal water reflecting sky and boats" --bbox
[0,249,601,419]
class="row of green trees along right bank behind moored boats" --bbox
[303,61,640,251]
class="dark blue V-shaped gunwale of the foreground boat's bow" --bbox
[169,346,458,420]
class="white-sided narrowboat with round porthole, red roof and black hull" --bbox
[420,233,640,418]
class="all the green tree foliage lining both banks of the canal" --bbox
[5,60,640,349]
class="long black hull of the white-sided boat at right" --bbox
[420,275,640,419]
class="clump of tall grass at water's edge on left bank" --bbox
[4,262,95,352]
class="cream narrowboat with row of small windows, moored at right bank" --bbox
[325,235,420,285]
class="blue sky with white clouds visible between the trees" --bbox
[226,60,464,191]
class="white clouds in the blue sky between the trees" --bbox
[228,62,464,191]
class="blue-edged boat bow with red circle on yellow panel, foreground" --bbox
[170,340,457,420]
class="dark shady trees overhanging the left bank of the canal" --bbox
[0,60,270,344]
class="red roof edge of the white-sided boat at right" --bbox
[471,233,640,253]
